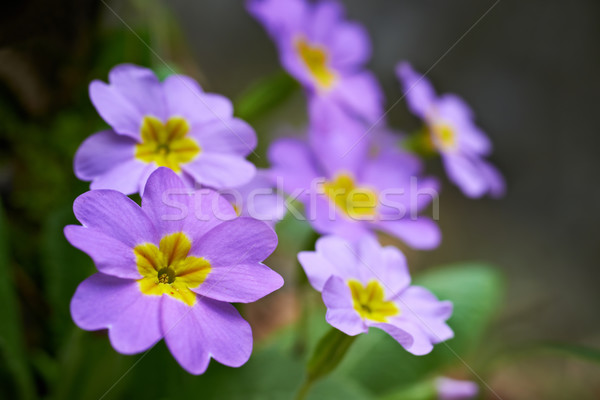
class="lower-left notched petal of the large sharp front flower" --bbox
[71,273,162,354]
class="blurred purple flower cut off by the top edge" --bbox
[248,0,383,121]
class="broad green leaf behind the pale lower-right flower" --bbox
[339,264,503,395]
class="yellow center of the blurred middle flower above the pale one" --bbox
[323,173,377,219]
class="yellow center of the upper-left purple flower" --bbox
[135,115,200,172]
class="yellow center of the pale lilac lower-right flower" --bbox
[348,279,400,322]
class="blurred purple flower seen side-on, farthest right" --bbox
[396,63,505,197]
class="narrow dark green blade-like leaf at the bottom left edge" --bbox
[0,204,35,400]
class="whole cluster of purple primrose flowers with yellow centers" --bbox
[65,0,504,395]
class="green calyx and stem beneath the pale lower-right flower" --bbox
[296,328,356,400]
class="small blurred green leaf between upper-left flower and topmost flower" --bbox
[234,71,299,121]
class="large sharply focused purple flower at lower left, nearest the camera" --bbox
[65,168,283,374]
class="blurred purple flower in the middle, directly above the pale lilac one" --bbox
[269,108,441,249]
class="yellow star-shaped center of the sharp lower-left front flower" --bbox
[133,232,210,306]
